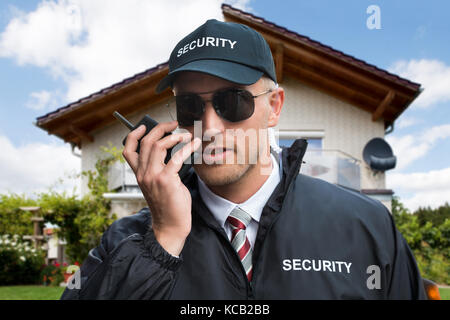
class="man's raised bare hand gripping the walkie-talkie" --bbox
[122,121,201,255]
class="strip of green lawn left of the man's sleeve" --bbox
[0,286,64,300]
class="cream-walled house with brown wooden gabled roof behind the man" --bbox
[36,4,421,216]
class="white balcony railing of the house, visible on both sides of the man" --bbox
[109,149,361,193]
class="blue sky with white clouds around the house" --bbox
[0,0,450,210]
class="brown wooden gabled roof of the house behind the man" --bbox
[36,4,421,147]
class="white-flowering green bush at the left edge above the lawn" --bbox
[0,235,45,286]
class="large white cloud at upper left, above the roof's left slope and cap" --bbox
[0,0,253,102]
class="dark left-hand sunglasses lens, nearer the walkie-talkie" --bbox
[176,94,204,127]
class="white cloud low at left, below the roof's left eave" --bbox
[0,136,81,195]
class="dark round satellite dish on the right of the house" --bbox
[363,138,397,172]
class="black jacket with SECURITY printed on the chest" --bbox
[61,139,426,299]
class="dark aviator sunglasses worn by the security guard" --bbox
[175,88,273,127]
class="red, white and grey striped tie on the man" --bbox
[227,206,253,281]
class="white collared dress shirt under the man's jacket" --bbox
[197,154,280,248]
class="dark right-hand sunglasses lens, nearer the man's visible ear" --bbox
[213,89,255,122]
